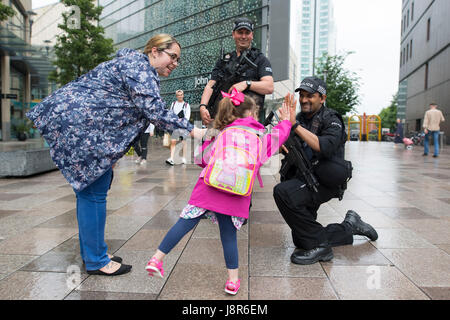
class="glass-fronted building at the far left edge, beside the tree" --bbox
[0,0,53,141]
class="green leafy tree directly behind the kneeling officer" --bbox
[316,52,360,115]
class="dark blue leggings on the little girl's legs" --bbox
[158,212,239,269]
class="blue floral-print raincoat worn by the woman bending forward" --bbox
[27,48,193,191]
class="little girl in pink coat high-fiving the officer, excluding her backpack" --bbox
[145,90,295,295]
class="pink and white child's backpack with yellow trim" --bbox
[203,126,263,196]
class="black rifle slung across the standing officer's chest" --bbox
[206,50,258,118]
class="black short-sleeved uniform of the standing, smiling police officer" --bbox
[209,48,272,118]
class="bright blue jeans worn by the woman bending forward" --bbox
[75,169,112,270]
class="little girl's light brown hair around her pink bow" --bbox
[214,95,259,130]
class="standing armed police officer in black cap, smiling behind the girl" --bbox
[200,18,273,125]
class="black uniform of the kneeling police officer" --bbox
[273,106,353,250]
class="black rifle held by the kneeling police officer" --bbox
[263,111,319,192]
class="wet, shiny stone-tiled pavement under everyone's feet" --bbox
[0,140,450,300]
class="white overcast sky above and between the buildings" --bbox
[32,0,402,114]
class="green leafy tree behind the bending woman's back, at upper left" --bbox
[49,0,114,85]
